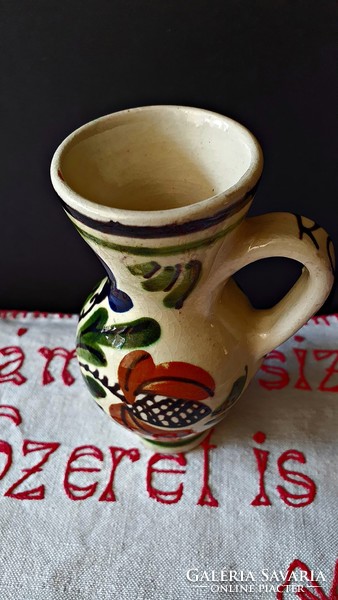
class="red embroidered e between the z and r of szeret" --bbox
[63,446,103,500]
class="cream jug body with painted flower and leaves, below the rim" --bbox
[69,185,257,452]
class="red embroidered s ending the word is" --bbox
[277,450,316,508]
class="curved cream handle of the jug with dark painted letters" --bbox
[227,213,335,358]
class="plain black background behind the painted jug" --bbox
[0,0,338,313]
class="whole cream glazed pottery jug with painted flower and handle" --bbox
[51,106,334,452]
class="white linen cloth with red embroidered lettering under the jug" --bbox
[0,311,338,600]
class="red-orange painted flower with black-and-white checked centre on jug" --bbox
[109,350,215,441]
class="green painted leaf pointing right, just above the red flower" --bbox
[105,317,161,350]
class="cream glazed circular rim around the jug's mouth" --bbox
[50,104,263,226]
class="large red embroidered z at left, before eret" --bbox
[4,440,60,500]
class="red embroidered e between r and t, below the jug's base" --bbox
[146,452,187,504]
